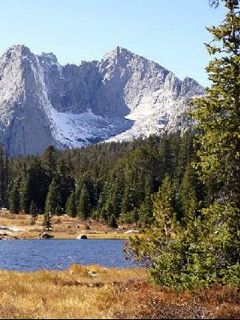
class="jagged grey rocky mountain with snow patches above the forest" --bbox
[0,45,204,156]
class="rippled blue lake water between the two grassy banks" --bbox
[0,240,136,271]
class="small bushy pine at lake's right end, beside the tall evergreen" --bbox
[130,176,178,286]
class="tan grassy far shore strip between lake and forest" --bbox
[0,211,139,240]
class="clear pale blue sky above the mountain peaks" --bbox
[0,0,224,85]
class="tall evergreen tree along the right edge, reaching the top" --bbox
[193,0,240,283]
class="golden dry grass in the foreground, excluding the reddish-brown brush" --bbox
[0,265,146,319]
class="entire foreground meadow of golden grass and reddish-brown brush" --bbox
[0,265,240,319]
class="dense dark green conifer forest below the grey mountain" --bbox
[0,131,206,226]
